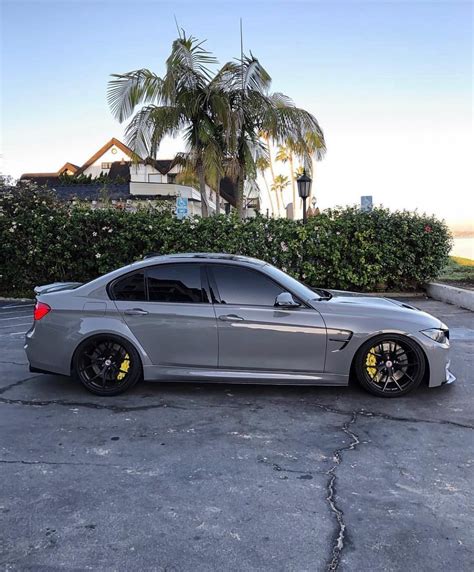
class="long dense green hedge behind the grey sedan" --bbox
[0,185,451,296]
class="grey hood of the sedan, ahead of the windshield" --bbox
[315,290,444,329]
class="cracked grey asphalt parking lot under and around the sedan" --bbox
[0,299,474,572]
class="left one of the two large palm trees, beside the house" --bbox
[108,32,230,216]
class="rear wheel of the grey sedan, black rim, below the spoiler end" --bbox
[71,334,142,396]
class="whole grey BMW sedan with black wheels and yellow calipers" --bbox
[25,254,455,397]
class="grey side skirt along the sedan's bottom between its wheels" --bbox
[143,366,349,386]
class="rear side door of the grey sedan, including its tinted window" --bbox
[110,263,217,369]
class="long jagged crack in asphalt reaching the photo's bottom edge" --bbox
[326,411,360,571]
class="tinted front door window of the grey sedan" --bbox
[211,265,285,306]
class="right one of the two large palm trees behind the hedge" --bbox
[216,54,324,217]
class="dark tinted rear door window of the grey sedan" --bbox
[147,264,207,303]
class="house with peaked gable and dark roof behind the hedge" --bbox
[20,138,256,214]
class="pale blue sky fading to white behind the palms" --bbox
[1,0,474,228]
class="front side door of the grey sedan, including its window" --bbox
[208,264,326,372]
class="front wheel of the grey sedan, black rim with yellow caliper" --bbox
[354,334,426,397]
